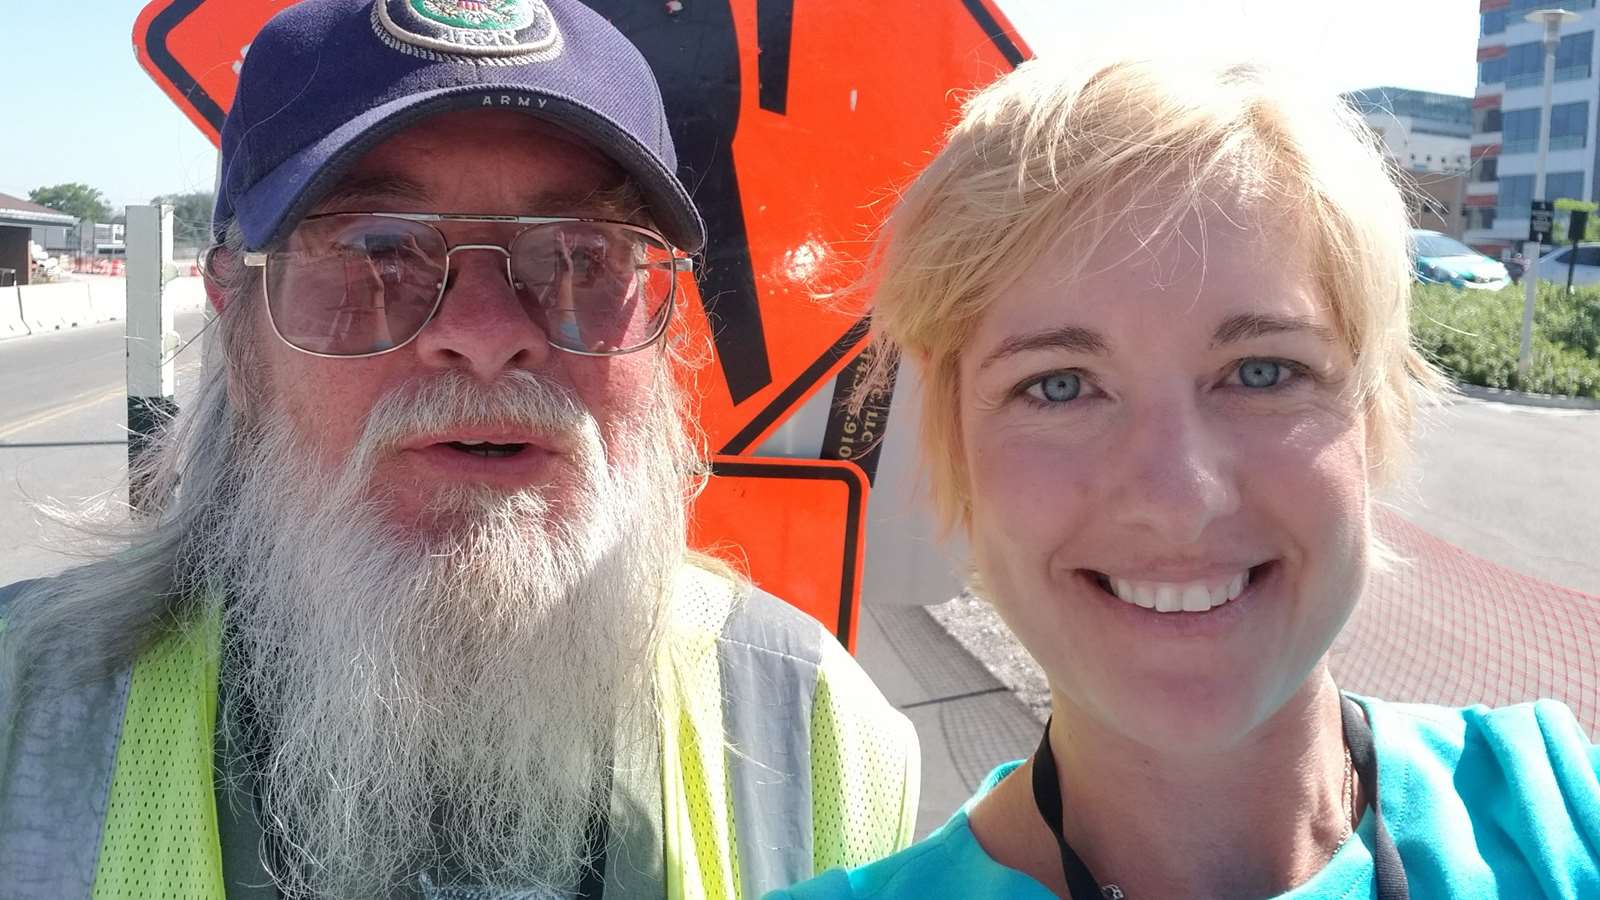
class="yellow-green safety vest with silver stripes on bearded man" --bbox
[0,569,918,900]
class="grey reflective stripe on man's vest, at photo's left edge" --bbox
[0,585,133,900]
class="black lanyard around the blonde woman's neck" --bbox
[1034,697,1411,900]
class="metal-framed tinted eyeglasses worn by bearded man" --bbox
[243,213,690,357]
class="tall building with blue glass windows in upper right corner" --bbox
[1466,0,1600,256]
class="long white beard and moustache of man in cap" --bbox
[206,368,690,897]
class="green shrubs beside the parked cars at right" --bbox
[1411,283,1600,399]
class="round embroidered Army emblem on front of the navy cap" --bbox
[373,0,562,62]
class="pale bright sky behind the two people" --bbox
[0,0,1478,207]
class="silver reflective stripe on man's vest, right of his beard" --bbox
[717,591,822,897]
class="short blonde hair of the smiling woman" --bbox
[867,59,1443,528]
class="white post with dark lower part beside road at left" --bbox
[128,207,178,512]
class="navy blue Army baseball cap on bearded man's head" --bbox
[211,0,706,253]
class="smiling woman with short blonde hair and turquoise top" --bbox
[778,61,1600,900]
